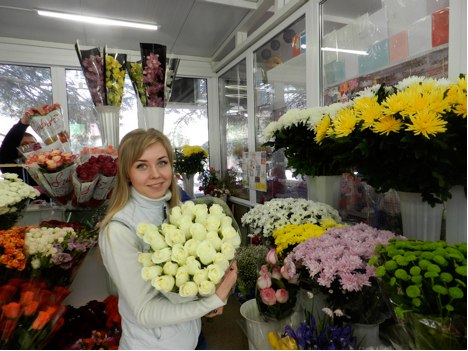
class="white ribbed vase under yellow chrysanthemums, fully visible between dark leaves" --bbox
[397,191,443,241]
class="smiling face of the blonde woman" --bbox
[129,142,172,199]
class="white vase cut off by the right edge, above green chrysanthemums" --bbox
[445,185,467,244]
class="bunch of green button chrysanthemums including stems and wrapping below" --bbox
[369,240,467,349]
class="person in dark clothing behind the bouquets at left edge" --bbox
[0,115,41,186]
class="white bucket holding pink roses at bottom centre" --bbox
[240,299,304,350]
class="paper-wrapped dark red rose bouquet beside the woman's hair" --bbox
[72,154,117,207]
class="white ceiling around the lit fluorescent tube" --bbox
[0,0,274,58]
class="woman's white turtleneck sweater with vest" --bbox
[99,188,225,350]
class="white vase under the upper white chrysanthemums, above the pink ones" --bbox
[307,175,341,210]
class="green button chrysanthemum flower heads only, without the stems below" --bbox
[369,240,466,318]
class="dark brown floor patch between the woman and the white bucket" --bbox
[202,295,249,350]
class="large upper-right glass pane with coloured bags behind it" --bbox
[320,0,450,105]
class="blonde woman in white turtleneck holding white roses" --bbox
[99,129,237,349]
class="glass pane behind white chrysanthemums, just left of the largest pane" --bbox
[254,17,307,203]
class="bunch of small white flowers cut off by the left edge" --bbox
[0,173,40,230]
